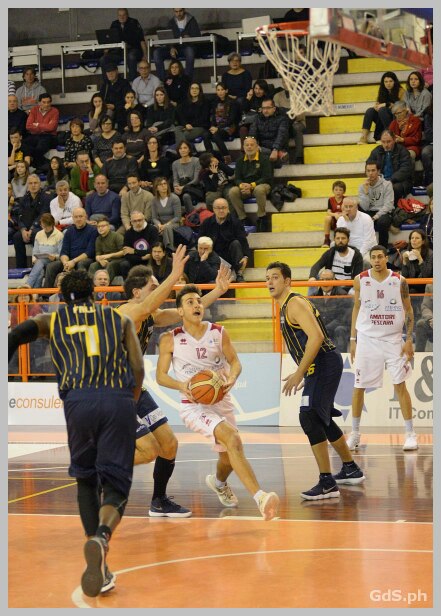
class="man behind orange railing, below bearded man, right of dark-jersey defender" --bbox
[310,270,350,353]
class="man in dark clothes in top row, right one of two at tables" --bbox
[153,9,201,81]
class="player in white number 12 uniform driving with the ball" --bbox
[156,285,279,520]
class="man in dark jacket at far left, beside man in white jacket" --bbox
[14,173,49,268]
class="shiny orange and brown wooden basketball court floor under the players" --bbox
[9,428,433,608]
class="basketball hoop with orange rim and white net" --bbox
[256,21,341,119]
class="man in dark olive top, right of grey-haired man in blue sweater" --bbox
[89,216,124,284]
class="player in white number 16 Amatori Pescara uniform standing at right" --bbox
[347,246,418,451]
